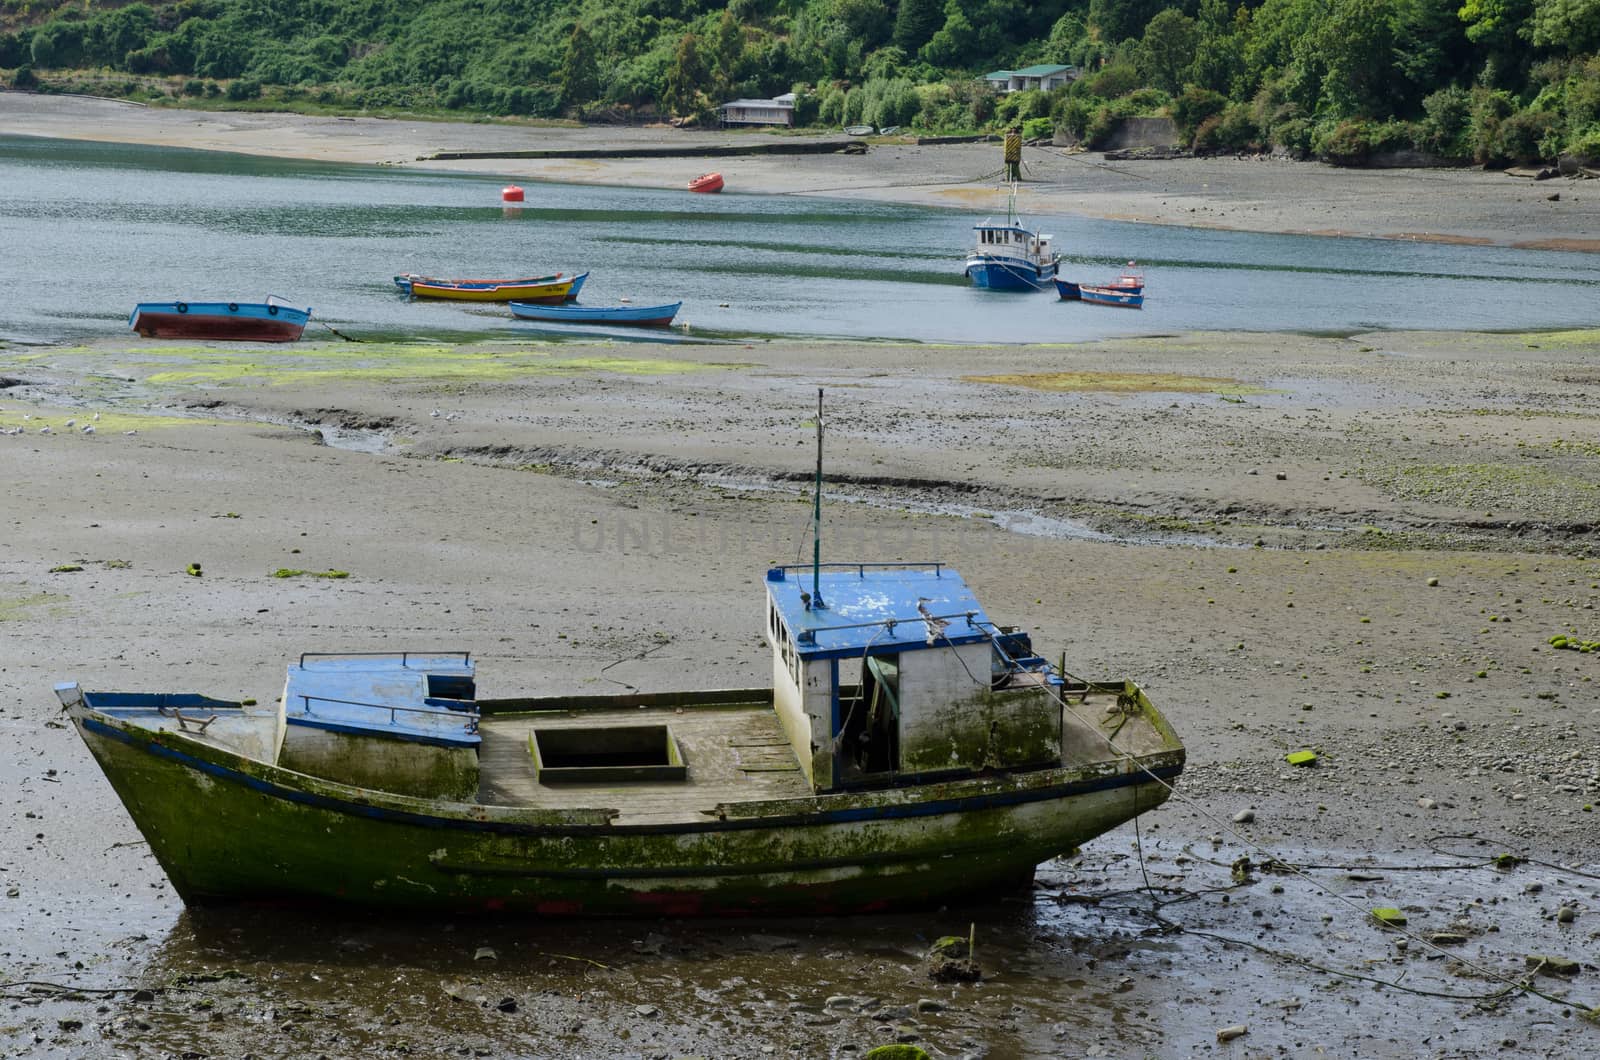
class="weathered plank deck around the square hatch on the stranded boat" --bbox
[478,705,811,825]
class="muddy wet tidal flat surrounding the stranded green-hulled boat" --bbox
[0,331,1600,1060]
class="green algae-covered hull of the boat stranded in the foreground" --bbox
[67,698,1184,916]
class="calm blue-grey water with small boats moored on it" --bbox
[0,136,1600,343]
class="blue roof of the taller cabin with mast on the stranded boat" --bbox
[766,564,994,660]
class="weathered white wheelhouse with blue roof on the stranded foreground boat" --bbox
[766,564,1061,794]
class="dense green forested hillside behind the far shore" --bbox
[0,0,1600,163]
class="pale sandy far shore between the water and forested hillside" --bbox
[9,93,1600,253]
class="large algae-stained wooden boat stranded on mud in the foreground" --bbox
[56,397,1184,916]
